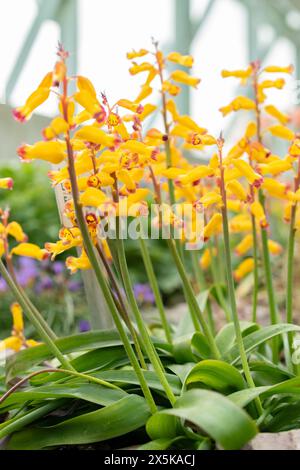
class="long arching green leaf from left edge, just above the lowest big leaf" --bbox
[0,383,127,411]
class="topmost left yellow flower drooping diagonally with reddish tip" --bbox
[13,72,53,122]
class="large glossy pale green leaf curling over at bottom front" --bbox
[147,389,258,450]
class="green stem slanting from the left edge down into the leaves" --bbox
[0,260,75,371]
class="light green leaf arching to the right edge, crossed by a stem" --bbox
[223,323,300,364]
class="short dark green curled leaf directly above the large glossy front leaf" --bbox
[185,359,245,394]
